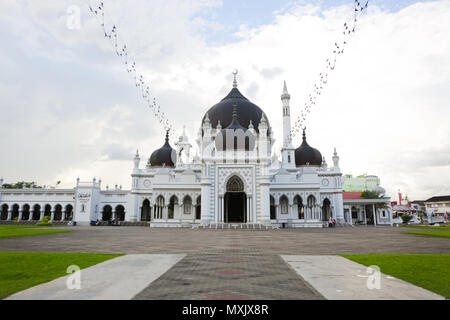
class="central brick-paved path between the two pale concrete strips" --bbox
[134,251,324,300]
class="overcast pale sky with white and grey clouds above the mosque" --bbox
[0,0,450,199]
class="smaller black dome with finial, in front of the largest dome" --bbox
[215,103,256,151]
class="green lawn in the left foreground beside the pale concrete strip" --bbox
[0,252,121,299]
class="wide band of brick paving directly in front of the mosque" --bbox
[0,227,450,255]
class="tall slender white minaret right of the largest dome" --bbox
[281,81,295,169]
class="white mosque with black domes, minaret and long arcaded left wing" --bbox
[0,76,389,228]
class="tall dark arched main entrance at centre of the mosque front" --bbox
[224,176,247,223]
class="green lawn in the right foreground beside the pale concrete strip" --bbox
[342,254,450,299]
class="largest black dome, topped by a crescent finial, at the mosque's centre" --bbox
[202,85,270,133]
